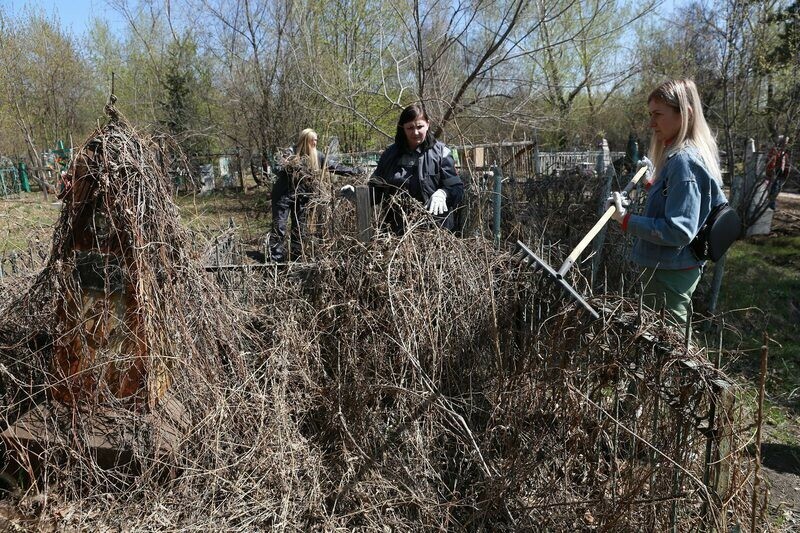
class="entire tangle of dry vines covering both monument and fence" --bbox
[0,111,748,531]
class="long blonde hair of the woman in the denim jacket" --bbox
[647,78,722,185]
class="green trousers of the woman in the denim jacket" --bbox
[643,268,703,326]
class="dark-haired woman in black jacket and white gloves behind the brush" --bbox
[370,104,464,233]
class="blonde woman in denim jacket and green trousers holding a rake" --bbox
[608,79,727,325]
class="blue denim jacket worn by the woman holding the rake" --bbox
[625,146,727,270]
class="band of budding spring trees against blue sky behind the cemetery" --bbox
[0,0,800,156]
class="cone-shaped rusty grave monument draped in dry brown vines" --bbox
[0,109,282,524]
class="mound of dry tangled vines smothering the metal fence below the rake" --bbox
[239,231,756,530]
